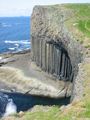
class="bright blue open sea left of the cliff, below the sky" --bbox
[0,17,30,53]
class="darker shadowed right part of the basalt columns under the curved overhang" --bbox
[47,41,74,82]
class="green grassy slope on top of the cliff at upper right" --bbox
[65,3,90,46]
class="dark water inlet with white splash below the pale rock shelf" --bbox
[0,91,70,117]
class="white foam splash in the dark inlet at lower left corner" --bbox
[4,99,17,117]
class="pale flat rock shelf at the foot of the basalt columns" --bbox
[0,51,72,98]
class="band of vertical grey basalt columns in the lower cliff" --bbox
[32,39,73,81]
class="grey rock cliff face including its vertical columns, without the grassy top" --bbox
[31,5,82,100]
